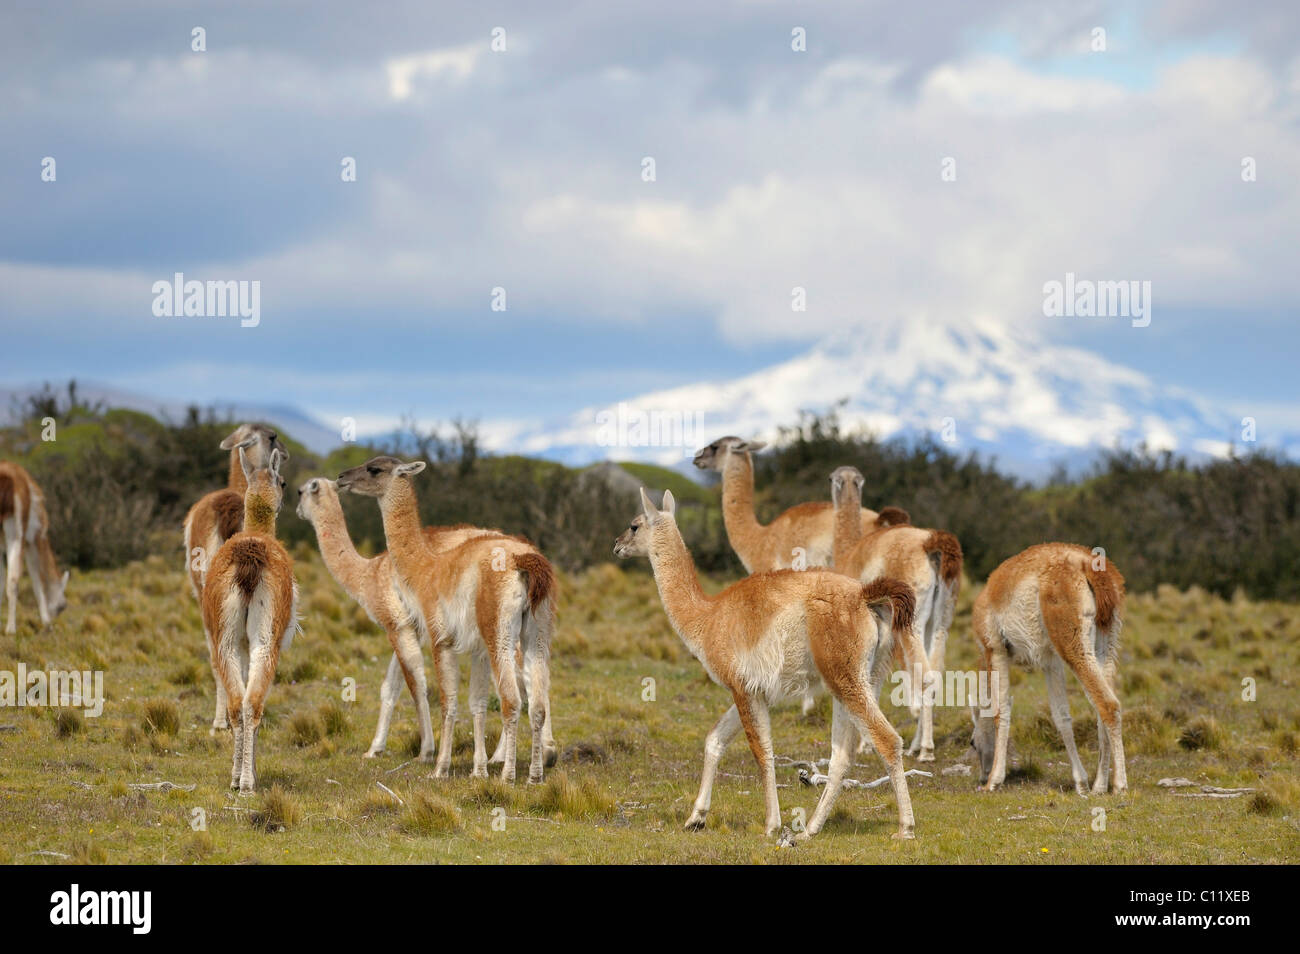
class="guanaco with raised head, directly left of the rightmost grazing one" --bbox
[831,467,962,762]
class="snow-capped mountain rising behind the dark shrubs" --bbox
[498,322,1300,478]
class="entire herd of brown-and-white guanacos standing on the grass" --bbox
[0,424,1127,838]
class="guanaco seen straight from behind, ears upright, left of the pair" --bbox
[203,445,298,794]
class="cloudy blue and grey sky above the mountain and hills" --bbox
[0,0,1300,452]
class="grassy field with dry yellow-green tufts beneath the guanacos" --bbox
[0,545,1300,863]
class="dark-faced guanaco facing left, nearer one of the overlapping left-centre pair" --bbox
[338,456,556,782]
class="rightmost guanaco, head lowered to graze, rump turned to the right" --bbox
[971,543,1128,795]
